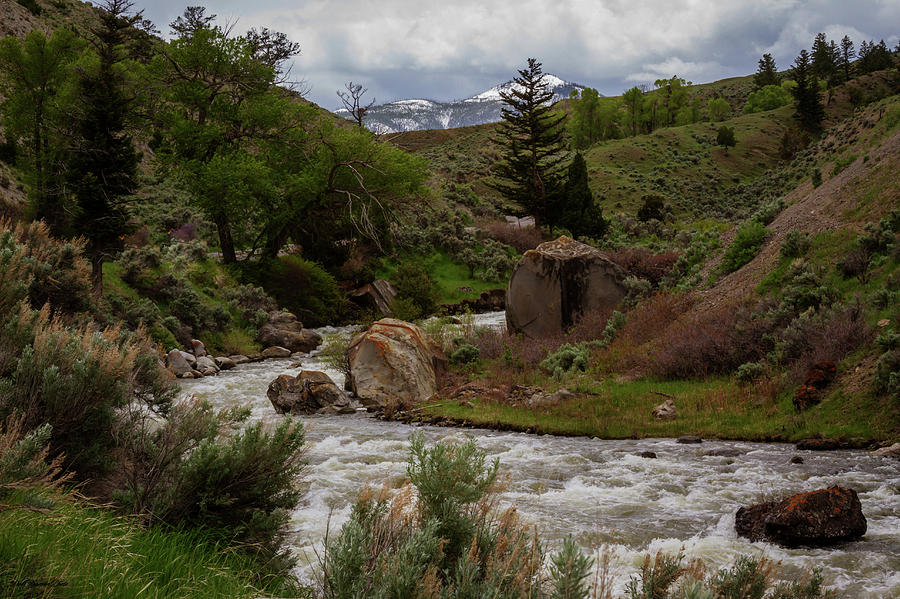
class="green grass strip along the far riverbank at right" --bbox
[423,378,896,441]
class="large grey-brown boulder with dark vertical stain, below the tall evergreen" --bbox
[506,236,626,338]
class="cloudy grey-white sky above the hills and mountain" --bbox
[135,0,900,109]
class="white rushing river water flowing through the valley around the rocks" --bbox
[182,313,900,599]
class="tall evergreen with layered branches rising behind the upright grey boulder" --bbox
[492,58,566,232]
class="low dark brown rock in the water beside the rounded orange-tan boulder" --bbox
[266,370,361,414]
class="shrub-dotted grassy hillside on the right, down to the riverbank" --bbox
[420,72,900,442]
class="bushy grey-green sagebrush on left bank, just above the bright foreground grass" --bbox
[117,401,306,571]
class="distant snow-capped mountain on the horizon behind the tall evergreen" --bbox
[336,73,584,133]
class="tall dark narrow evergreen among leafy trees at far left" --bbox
[65,0,140,295]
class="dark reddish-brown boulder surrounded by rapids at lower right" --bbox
[734,487,866,547]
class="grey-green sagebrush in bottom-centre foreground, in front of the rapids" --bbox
[322,435,586,599]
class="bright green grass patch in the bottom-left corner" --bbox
[0,498,297,599]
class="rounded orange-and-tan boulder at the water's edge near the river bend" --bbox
[348,318,447,406]
